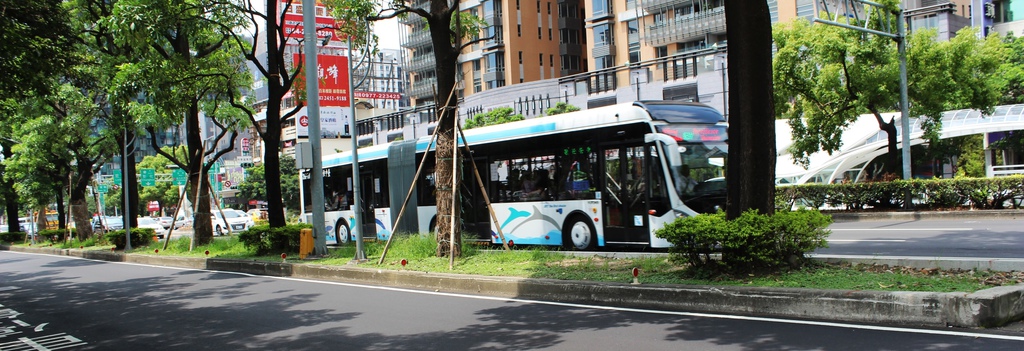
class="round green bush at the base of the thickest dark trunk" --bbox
[655,210,831,272]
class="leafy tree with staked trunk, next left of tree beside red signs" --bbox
[101,0,251,245]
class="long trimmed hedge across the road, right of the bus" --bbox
[775,175,1024,210]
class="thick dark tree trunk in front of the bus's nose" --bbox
[725,1,775,218]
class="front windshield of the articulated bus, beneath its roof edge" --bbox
[658,124,729,213]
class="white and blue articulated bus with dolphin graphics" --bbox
[302,101,728,250]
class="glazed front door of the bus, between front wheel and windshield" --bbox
[601,145,650,245]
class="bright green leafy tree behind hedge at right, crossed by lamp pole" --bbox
[773,7,1006,179]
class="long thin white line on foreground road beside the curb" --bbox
[9,252,1024,342]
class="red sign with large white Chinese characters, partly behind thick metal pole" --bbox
[293,53,349,107]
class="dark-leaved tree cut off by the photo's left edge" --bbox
[0,0,75,233]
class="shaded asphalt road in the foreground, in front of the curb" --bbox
[0,252,1024,350]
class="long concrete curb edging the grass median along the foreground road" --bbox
[0,246,1024,327]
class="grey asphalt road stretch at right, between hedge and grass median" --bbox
[816,219,1024,258]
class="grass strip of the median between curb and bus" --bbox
[12,235,1024,293]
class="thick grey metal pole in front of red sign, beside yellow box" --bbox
[302,0,327,255]
